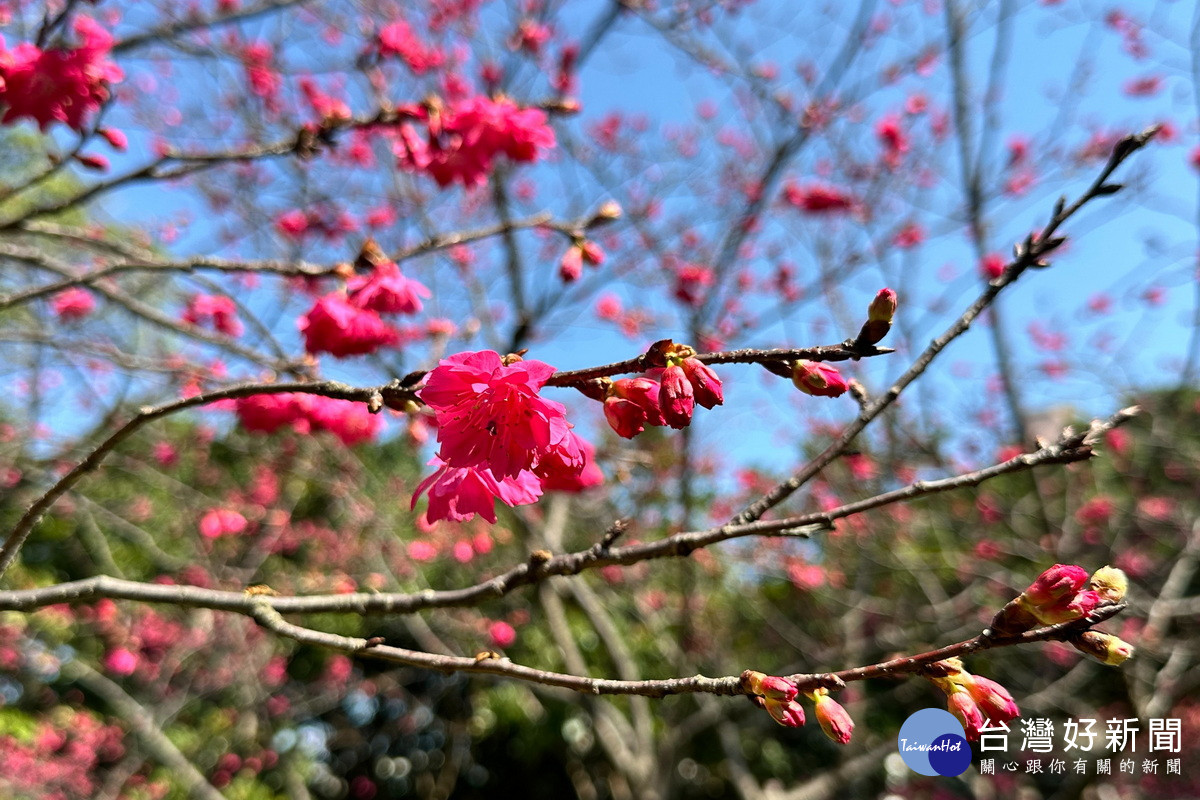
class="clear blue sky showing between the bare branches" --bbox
[30,0,1196,489]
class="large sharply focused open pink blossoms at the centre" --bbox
[413,350,602,523]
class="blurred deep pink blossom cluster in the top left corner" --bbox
[0,17,125,131]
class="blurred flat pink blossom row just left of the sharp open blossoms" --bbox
[234,392,383,447]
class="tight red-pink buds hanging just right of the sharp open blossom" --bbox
[604,344,725,439]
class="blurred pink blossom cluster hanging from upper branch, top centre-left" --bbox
[394,96,556,188]
